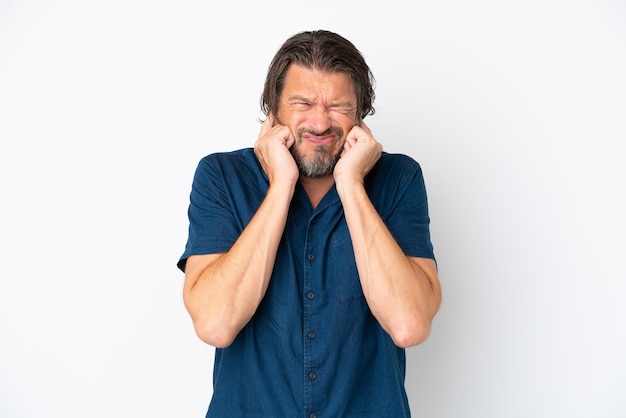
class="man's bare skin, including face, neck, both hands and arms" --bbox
[183,64,441,347]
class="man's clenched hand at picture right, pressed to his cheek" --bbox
[333,122,383,183]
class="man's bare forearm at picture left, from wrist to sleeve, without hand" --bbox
[184,183,293,346]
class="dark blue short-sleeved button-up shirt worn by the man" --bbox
[178,148,434,418]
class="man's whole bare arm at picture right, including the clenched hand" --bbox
[334,124,441,347]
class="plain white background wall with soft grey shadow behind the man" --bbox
[0,0,626,418]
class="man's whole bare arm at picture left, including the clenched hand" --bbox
[183,117,298,347]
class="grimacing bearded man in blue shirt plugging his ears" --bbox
[178,31,441,418]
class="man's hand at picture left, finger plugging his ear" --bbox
[254,114,300,186]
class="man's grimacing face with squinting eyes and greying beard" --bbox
[276,64,357,177]
